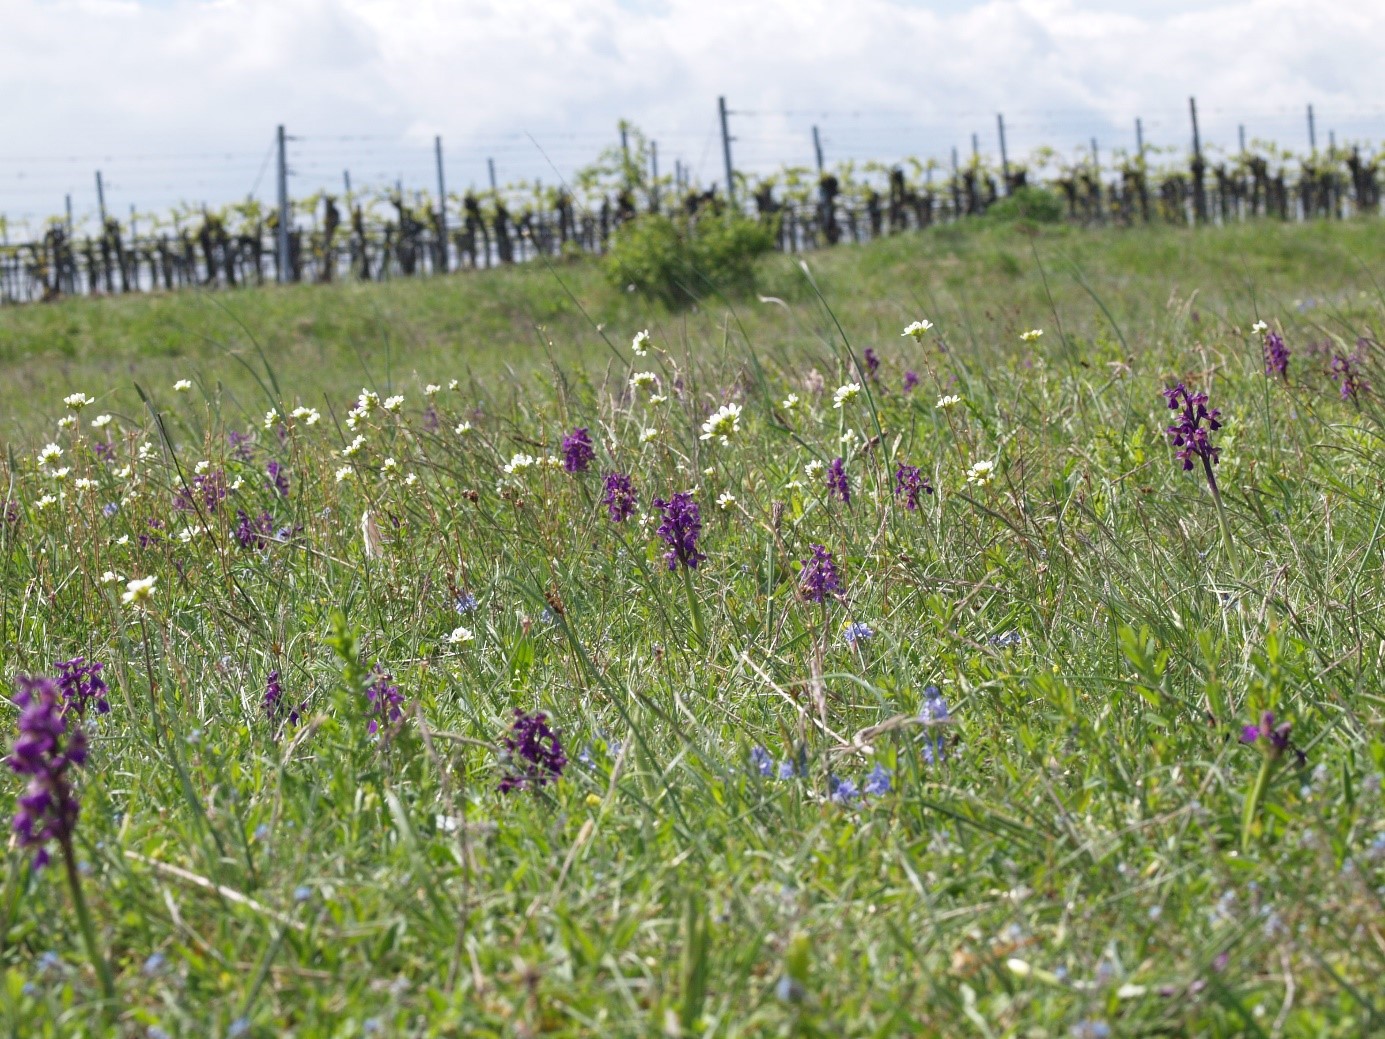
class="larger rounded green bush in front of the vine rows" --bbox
[605,213,774,306]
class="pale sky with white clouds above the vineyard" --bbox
[0,0,1385,234]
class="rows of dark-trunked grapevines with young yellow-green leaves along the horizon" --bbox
[0,119,1385,303]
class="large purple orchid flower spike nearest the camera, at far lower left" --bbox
[6,675,87,870]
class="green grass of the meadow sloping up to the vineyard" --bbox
[0,216,1385,1038]
